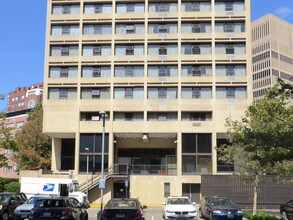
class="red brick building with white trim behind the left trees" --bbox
[0,82,43,178]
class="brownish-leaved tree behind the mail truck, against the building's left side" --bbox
[15,104,51,170]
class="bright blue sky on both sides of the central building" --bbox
[0,0,293,111]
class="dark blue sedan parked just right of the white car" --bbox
[199,196,243,220]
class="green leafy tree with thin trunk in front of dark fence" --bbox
[216,80,293,214]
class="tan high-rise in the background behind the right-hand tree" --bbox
[251,14,293,99]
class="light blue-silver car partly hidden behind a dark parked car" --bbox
[14,195,49,220]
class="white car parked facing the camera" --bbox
[163,196,197,219]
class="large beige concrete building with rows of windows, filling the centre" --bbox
[43,0,252,205]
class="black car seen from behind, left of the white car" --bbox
[100,198,147,220]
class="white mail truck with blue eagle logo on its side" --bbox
[20,177,87,203]
